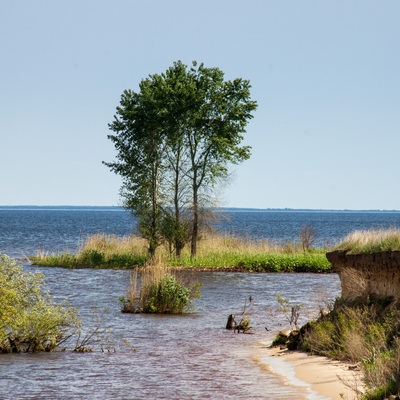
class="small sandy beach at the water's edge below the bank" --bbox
[256,345,362,400]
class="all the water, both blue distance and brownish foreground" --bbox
[0,207,400,400]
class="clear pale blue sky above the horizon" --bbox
[0,0,400,209]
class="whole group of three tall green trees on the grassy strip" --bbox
[105,61,257,257]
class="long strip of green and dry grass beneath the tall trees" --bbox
[30,234,331,272]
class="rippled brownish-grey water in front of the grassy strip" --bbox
[0,267,340,400]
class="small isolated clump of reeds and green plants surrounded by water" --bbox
[120,263,200,314]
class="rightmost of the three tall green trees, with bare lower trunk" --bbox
[181,63,257,257]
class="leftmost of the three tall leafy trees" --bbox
[104,80,165,257]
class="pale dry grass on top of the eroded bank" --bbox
[335,228,400,254]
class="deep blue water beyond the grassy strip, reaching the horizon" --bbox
[0,207,400,258]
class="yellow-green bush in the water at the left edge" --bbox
[0,255,80,353]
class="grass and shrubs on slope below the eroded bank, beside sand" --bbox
[299,301,400,400]
